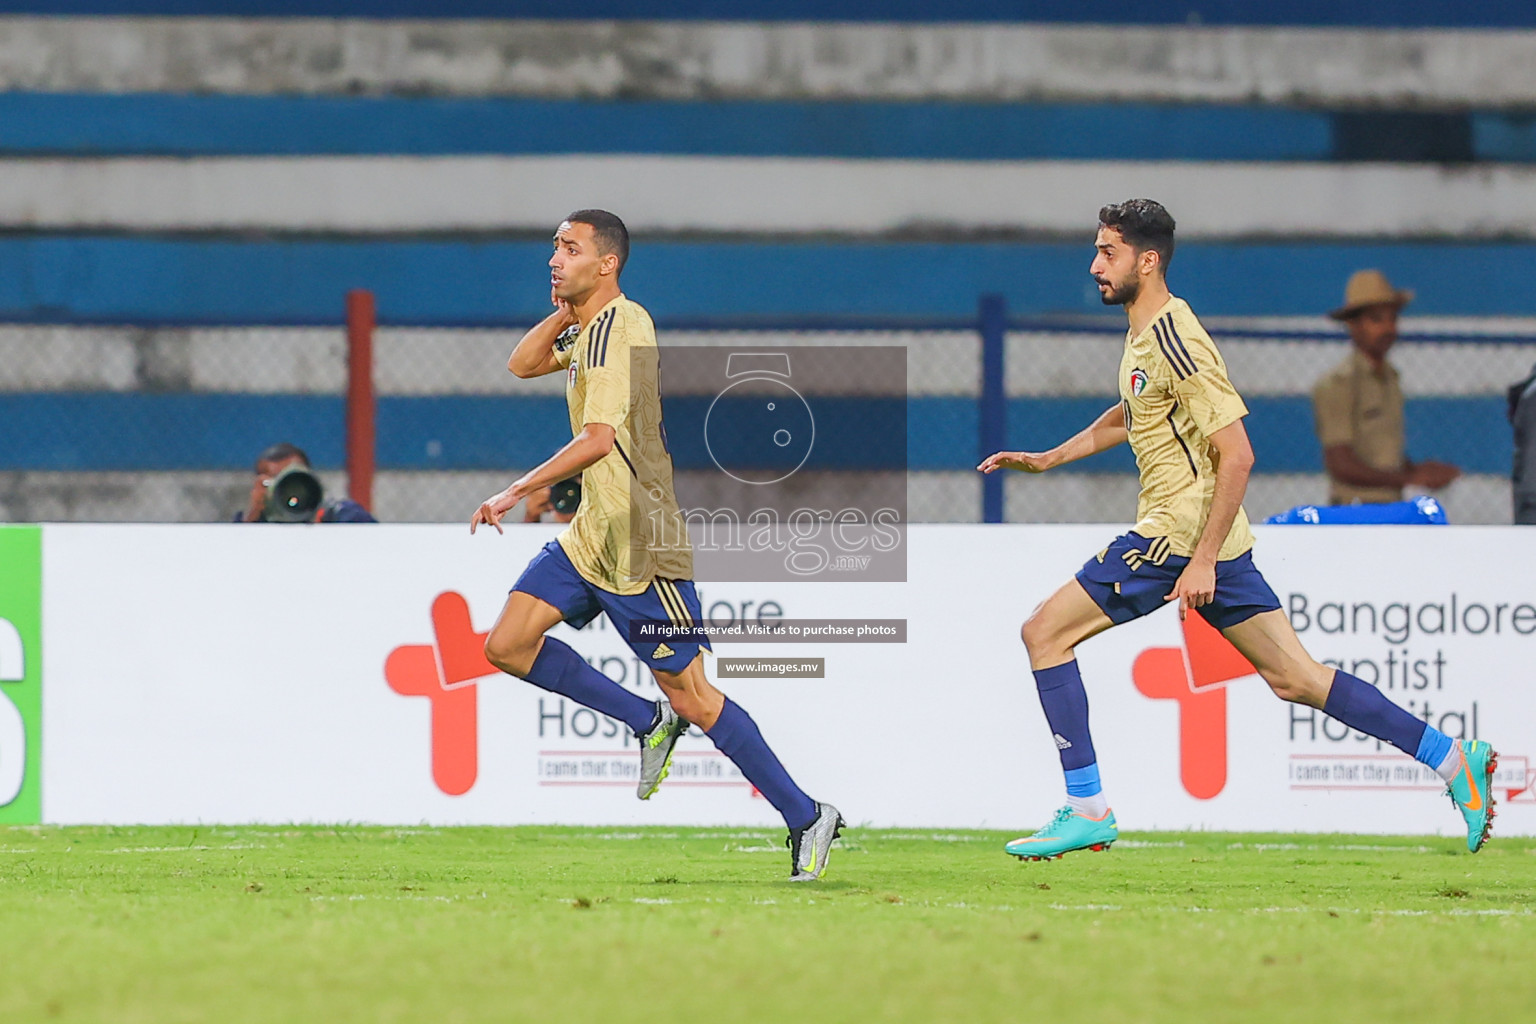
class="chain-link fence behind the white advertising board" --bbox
[0,319,1536,524]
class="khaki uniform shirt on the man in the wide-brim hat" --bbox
[1312,347,1407,505]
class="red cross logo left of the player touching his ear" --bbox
[384,591,499,797]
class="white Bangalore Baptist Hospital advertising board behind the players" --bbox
[33,525,1536,835]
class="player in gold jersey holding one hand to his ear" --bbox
[470,210,843,881]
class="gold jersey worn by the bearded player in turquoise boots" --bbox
[1120,298,1253,562]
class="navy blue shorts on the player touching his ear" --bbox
[511,540,711,672]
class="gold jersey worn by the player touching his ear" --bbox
[554,295,693,594]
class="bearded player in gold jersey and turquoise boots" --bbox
[977,200,1498,860]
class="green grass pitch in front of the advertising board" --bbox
[0,827,1536,1024]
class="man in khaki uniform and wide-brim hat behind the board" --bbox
[1312,270,1461,505]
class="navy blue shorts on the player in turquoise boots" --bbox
[1077,533,1279,629]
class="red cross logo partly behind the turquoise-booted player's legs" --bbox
[1130,614,1258,800]
